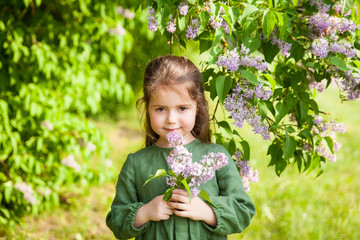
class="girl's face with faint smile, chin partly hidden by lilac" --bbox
[148,83,197,147]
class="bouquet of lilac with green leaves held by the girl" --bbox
[144,131,229,203]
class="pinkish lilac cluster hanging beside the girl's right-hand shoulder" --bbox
[233,150,259,192]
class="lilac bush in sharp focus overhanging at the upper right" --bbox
[139,0,360,178]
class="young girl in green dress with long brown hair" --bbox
[106,55,255,240]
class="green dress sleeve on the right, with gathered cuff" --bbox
[203,149,255,235]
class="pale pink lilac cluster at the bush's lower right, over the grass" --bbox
[310,115,346,162]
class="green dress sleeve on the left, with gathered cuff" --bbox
[106,154,150,239]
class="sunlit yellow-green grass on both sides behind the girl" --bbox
[0,88,360,240]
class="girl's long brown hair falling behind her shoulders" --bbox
[137,55,210,146]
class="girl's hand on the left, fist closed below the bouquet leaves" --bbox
[134,195,173,228]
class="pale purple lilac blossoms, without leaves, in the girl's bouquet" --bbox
[166,131,229,196]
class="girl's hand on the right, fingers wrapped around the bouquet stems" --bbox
[168,189,217,227]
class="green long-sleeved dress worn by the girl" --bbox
[106,139,255,240]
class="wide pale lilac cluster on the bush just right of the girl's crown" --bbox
[216,45,267,72]
